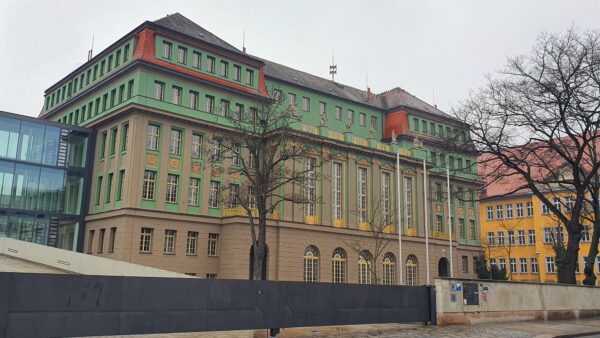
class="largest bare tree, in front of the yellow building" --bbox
[455,28,600,284]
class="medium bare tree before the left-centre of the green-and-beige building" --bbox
[207,100,321,280]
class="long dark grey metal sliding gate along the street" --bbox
[0,273,436,337]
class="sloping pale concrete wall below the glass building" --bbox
[0,237,192,278]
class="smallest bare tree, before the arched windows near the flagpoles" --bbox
[344,199,399,284]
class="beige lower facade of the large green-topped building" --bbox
[84,108,480,284]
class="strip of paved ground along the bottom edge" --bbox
[95,318,600,338]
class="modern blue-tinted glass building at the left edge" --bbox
[0,111,94,251]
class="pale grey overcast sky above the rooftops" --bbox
[0,0,600,116]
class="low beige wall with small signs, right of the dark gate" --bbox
[435,279,600,325]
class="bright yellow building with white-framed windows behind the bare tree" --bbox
[479,190,600,284]
